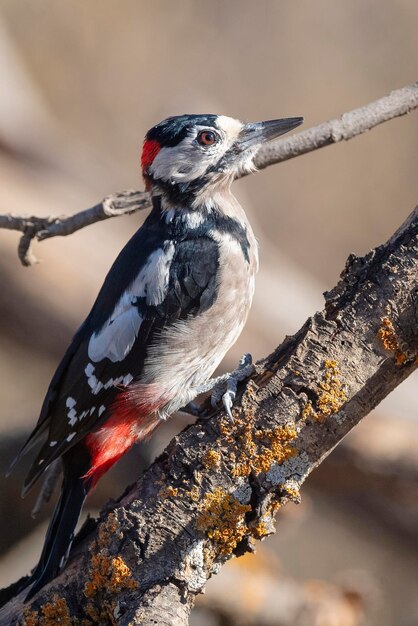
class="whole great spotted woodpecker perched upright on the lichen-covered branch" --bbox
[13,115,303,597]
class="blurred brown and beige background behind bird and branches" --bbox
[0,0,418,626]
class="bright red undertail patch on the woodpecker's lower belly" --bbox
[83,392,161,488]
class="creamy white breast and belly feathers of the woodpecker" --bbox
[138,231,256,418]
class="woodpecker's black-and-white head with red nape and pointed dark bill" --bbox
[141,115,303,200]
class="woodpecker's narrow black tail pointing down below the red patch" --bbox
[26,477,88,600]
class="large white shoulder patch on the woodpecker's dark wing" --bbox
[86,241,175,364]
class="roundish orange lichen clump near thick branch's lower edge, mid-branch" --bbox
[196,487,251,555]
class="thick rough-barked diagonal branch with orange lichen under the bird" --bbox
[0,207,418,626]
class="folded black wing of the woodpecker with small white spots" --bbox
[24,227,219,492]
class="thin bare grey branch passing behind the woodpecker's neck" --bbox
[0,83,418,266]
